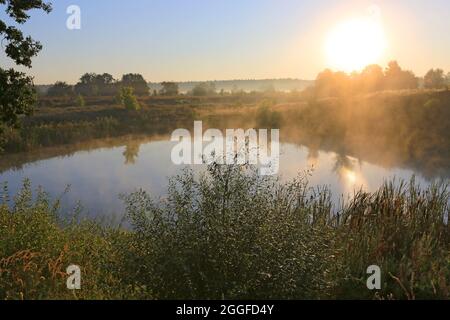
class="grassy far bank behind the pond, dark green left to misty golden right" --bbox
[3,89,450,178]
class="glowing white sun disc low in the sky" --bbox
[326,17,386,72]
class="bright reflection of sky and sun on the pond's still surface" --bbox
[0,141,432,220]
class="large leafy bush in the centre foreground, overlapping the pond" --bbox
[126,165,336,299]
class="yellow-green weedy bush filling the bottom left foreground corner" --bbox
[0,181,139,300]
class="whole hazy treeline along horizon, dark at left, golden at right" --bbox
[41,61,450,98]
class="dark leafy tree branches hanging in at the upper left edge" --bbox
[0,0,51,130]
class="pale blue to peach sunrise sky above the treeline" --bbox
[0,0,450,84]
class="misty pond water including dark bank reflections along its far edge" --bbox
[0,125,438,218]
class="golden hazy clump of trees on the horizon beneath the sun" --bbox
[304,61,450,98]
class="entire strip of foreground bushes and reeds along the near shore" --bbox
[0,165,450,299]
